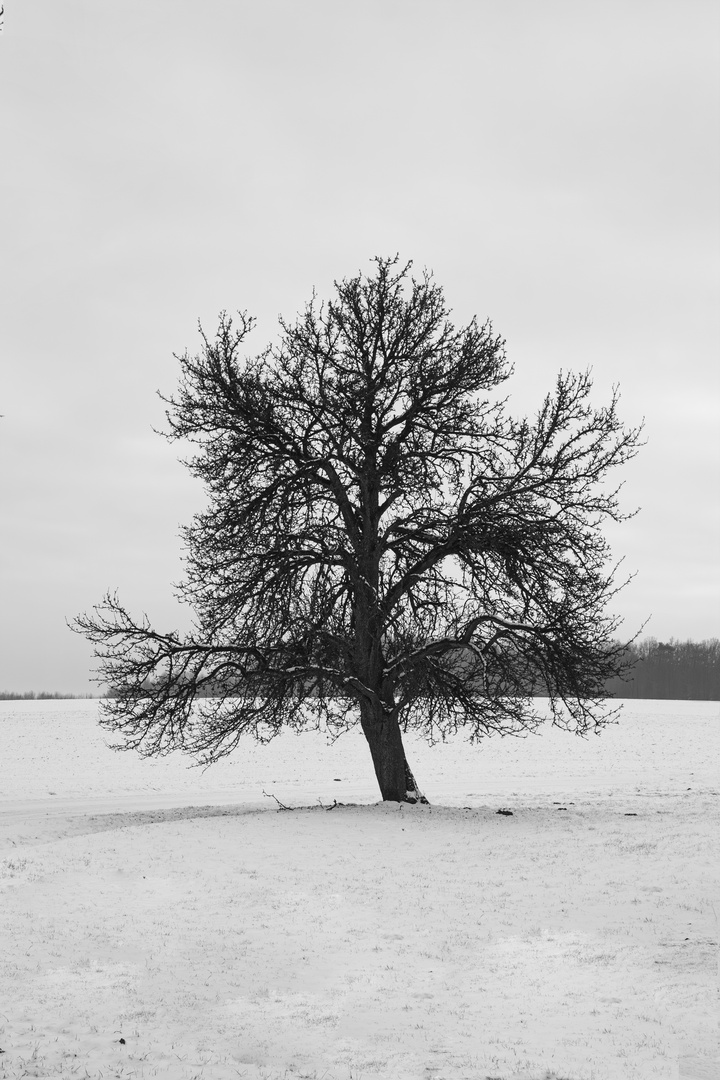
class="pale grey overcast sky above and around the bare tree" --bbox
[0,0,720,691]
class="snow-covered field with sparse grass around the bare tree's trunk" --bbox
[0,701,720,1080]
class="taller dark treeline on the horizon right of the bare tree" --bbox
[607,637,720,701]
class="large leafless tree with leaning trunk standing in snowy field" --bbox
[73,258,639,801]
